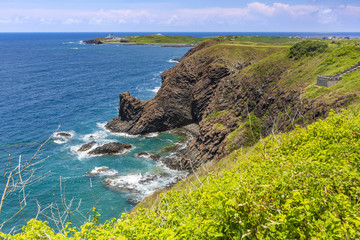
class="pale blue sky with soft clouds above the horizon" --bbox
[0,0,360,32]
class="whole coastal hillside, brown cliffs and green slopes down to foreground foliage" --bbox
[3,38,360,239]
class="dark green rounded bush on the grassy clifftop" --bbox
[288,40,328,60]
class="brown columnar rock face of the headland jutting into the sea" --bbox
[106,40,229,134]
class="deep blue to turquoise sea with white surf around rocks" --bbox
[0,33,360,232]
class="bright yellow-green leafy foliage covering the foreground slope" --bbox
[1,109,360,239]
